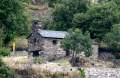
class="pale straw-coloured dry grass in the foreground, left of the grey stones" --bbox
[2,56,80,78]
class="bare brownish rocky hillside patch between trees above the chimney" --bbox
[27,0,49,21]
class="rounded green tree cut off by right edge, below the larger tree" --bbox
[104,24,120,50]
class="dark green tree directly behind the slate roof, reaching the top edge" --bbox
[44,0,88,30]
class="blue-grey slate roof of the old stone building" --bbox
[38,30,67,38]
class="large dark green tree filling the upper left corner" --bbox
[0,0,29,44]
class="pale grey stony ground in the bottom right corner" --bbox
[84,68,120,78]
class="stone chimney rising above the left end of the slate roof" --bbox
[32,20,42,32]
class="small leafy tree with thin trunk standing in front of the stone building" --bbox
[61,29,92,63]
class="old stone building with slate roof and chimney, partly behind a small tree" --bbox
[27,20,98,58]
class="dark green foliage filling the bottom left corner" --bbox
[0,59,17,78]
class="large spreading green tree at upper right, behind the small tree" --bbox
[73,2,120,40]
